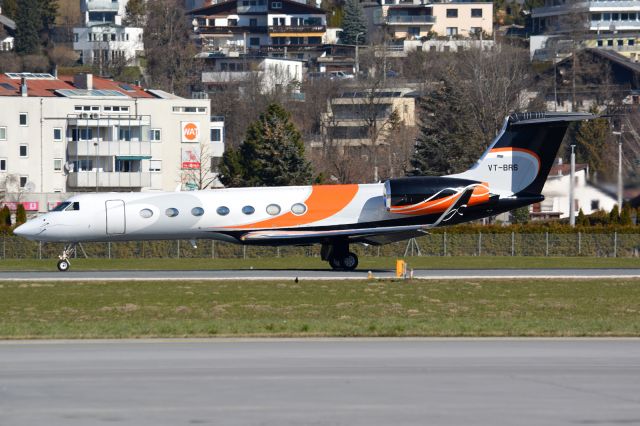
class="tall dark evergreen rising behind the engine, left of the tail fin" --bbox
[410,82,482,176]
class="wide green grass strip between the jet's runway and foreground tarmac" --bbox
[0,279,640,339]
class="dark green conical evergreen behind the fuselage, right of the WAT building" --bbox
[221,103,312,186]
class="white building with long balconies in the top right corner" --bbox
[530,0,640,60]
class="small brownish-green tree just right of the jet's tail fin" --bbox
[576,109,611,180]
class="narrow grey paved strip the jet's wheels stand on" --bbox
[0,269,640,281]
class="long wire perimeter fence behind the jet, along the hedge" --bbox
[0,232,640,259]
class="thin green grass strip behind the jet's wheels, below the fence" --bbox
[0,256,640,271]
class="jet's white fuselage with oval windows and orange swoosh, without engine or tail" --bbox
[16,184,398,242]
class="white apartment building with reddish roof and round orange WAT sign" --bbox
[0,73,224,211]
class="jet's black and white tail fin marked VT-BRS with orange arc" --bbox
[455,112,595,195]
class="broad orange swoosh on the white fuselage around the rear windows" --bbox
[226,185,358,229]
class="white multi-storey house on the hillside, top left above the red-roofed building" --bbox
[73,0,144,64]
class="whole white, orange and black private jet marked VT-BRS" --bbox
[14,112,594,271]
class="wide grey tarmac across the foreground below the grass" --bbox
[0,339,640,426]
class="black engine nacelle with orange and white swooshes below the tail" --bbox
[384,176,489,214]
